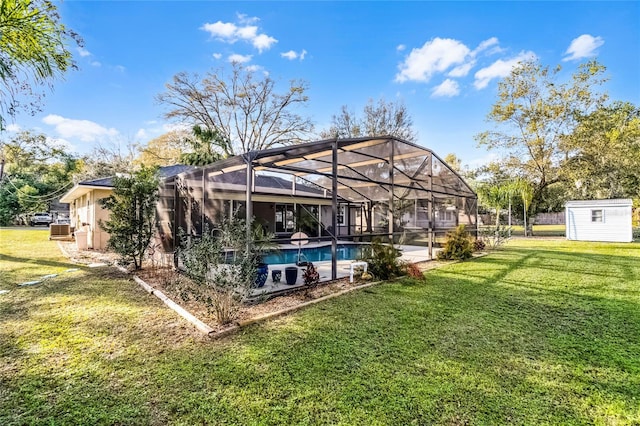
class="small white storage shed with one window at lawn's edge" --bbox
[565,199,633,243]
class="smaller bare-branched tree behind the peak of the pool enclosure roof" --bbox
[320,99,417,142]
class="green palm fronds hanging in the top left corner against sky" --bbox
[0,0,82,130]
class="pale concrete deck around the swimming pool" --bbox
[251,243,439,298]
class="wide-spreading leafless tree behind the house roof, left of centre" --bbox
[156,63,313,155]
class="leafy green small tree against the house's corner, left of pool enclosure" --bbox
[99,167,158,270]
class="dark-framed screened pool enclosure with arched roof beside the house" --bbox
[159,136,477,279]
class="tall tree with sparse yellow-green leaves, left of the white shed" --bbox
[476,61,606,212]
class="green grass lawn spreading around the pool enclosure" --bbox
[0,230,640,425]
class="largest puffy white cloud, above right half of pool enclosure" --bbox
[396,37,470,83]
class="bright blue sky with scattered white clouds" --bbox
[10,0,640,166]
